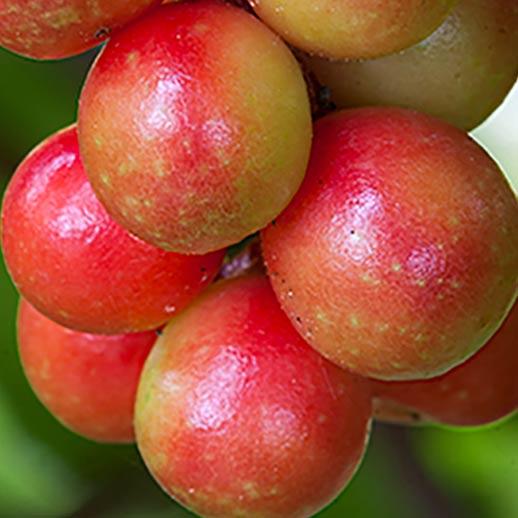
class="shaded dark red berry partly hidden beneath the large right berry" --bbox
[372,304,518,426]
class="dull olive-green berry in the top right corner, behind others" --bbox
[307,0,518,130]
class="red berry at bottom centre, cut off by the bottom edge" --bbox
[135,276,371,518]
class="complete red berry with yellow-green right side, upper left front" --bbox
[79,1,311,253]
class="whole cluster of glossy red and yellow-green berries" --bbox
[0,0,518,518]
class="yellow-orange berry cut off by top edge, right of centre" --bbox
[250,0,457,59]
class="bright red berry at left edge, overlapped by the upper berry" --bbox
[2,126,224,334]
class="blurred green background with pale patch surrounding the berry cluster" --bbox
[0,46,518,518]
